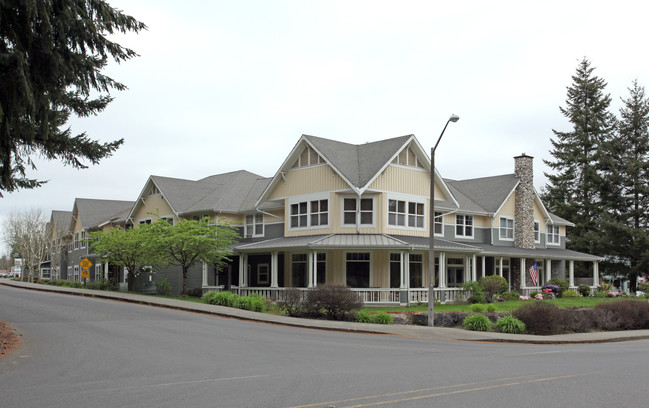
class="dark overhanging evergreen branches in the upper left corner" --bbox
[0,0,146,192]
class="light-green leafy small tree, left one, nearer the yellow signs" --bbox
[90,225,162,292]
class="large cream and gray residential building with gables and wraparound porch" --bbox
[44,135,601,304]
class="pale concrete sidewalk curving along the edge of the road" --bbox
[5,279,649,344]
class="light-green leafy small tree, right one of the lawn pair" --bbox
[150,217,239,294]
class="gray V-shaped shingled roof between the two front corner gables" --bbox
[304,135,412,188]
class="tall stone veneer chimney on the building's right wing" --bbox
[514,153,535,249]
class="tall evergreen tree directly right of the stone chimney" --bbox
[543,58,615,260]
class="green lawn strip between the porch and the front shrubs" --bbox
[363,297,619,313]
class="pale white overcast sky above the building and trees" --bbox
[0,0,649,255]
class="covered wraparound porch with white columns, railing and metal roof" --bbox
[203,234,600,305]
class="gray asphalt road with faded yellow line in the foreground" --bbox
[0,286,649,408]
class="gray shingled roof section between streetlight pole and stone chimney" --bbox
[446,174,518,214]
